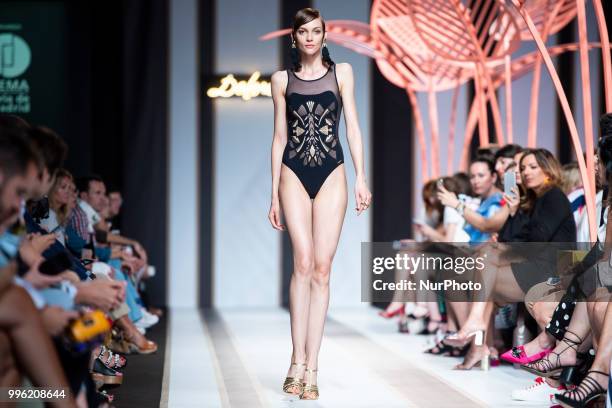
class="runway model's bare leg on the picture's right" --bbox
[304,165,347,398]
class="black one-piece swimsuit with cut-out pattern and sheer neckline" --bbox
[283,65,344,198]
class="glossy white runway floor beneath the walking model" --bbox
[162,306,549,408]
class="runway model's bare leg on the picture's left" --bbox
[278,165,314,393]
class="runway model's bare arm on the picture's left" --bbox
[268,71,287,230]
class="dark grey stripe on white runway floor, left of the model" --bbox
[201,309,262,408]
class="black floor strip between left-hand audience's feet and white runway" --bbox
[110,311,169,408]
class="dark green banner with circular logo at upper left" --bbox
[0,1,67,134]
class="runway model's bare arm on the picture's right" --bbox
[336,63,372,214]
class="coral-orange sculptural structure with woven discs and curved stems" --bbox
[261,0,612,241]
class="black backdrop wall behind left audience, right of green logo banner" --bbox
[0,0,168,304]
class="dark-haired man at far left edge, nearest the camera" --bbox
[0,116,76,407]
